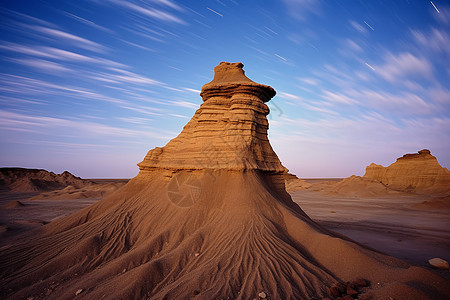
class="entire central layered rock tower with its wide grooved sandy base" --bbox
[0,63,450,299]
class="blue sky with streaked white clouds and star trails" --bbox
[0,0,450,178]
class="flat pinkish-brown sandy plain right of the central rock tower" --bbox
[291,179,450,266]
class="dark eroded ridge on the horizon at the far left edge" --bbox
[0,168,89,193]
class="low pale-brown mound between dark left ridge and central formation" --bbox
[30,182,125,200]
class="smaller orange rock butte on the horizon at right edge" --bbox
[364,149,450,194]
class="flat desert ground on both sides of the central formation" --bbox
[0,178,450,278]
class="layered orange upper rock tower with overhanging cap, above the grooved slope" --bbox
[138,62,284,173]
